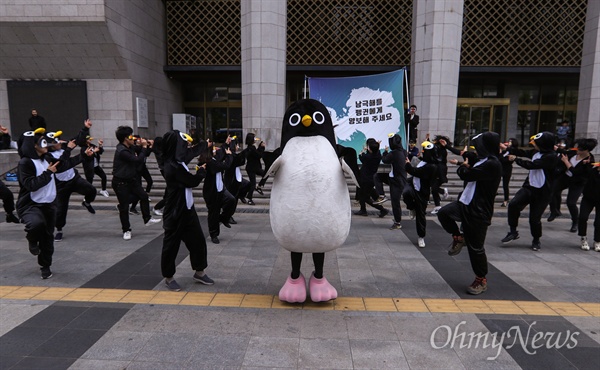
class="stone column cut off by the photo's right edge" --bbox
[575,1,600,154]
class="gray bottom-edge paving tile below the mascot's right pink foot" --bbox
[298,338,353,369]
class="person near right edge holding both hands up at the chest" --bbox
[548,138,598,233]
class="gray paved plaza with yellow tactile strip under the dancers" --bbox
[0,204,600,370]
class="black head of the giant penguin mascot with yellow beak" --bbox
[280,99,336,150]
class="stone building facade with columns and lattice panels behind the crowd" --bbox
[0,0,600,149]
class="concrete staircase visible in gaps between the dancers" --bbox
[2,149,568,215]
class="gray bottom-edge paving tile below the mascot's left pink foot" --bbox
[242,337,300,367]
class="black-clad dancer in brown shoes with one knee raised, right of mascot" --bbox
[437,132,502,294]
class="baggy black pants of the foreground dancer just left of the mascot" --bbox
[160,207,208,278]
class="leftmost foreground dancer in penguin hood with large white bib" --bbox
[17,128,60,279]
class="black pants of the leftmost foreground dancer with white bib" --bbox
[18,202,56,267]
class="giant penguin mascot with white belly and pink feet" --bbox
[266,99,356,303]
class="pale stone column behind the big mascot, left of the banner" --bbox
[241,0,287,150]
